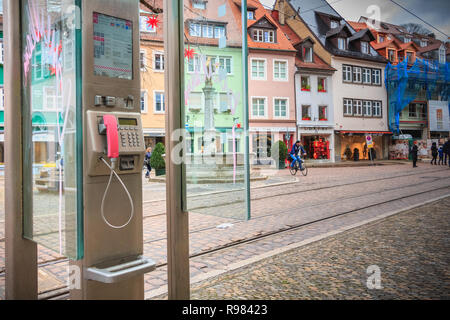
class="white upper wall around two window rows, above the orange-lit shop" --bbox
[332,57,389,131]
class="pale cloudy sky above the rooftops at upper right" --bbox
[260,0,450,40]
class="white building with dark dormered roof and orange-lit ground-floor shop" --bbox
[274,0,392,161]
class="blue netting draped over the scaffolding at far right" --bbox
[385,58,450,133]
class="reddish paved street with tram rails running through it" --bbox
[0,164,450,299]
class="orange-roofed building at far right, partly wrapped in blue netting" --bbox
[350,17,448,140]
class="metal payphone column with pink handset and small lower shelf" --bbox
[71,0,155,299]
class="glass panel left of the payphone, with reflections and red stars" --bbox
[21,0,83,259]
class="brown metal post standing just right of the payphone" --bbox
[164,0,190,300]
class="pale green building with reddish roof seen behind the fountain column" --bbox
[184,1,244,154]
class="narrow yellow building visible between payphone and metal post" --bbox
[140,3,165,147]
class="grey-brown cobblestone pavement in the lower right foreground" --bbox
[191,198,450,299]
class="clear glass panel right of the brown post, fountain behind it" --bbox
[182,0,249,220]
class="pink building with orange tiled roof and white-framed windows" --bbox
[239,0,296,163]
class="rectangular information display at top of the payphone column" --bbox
[94,13,133,80]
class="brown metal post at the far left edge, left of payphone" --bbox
[3,0,38,300]
